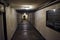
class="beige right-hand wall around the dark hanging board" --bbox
[35,3,60,40]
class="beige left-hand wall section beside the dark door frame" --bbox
[6,7,17,40]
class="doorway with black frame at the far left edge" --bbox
[0,3,7,40]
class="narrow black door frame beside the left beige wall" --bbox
[0,2,7,40]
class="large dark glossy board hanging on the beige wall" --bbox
[46,9,60,32]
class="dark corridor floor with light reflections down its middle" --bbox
[12,21,45,40]
